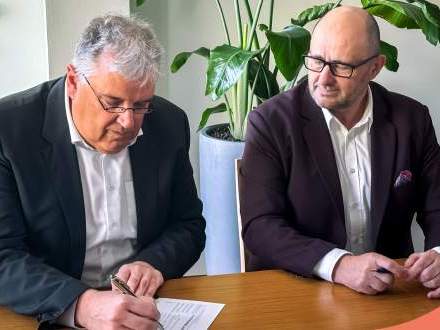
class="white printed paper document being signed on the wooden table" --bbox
[156,298,225,330]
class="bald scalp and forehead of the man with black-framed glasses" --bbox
[312,6,380,56]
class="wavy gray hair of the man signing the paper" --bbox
[72,15,163,84]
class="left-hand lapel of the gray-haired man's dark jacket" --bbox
[41,79,86,277]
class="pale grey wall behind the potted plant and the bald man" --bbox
[135,0,440,272]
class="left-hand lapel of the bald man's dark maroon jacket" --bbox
[302,91,345,227]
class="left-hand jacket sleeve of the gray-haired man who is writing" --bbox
[0,144,88,322]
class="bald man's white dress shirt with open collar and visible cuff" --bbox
[313,88,373,281]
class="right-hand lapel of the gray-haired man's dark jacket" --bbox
[129,115,158,244]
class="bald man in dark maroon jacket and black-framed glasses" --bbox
[240,7,440,298]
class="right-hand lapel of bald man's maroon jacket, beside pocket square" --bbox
[371,84,396,244]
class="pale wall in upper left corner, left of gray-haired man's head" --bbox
[0,0,130,97]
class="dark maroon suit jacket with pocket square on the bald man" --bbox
[240,82,440,276]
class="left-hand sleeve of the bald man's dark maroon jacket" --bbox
[240,111,337,277]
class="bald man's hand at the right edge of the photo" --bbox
[405,250,440,298]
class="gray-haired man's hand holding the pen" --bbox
[75,289,159,330]
